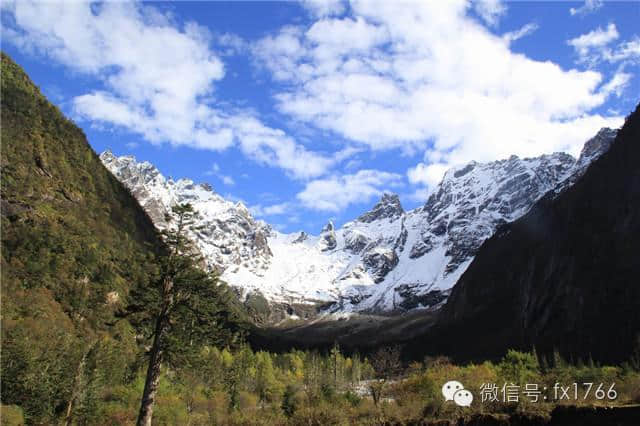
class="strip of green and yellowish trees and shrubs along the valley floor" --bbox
[3,341,640,425]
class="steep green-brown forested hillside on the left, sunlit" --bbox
[2,53,160,422]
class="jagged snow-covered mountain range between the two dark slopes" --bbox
[100,129,616,312]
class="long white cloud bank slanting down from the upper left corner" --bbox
[3,0,333,179]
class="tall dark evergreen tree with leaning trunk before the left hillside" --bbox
[137,204,238,426]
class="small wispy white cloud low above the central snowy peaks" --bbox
[297,170,402,212]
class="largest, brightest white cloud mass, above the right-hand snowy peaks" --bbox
[254,0,633,188]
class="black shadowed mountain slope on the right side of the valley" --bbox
[421,109,640,363]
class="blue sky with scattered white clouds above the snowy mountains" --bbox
[2,0,640,233]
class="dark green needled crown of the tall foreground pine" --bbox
[136,204,243,368]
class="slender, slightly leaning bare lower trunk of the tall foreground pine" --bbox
[136,280,173,426]
